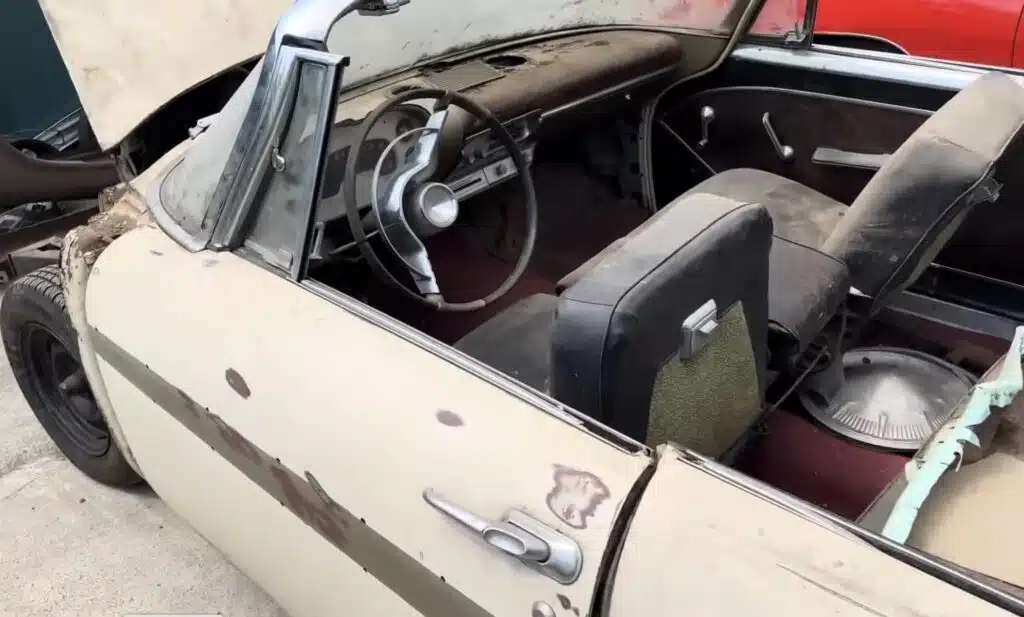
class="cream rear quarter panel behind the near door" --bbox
[609,446,1011,617]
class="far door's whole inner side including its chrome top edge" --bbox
[654,45,1024,284]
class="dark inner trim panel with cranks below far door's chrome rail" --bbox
[664,86,929,204]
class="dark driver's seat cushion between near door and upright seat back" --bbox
[455,294,558,392]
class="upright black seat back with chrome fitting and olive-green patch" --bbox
[551,193,772,456]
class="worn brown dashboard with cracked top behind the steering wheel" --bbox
[307,30,684,253]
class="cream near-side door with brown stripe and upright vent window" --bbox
[86,50,650,617]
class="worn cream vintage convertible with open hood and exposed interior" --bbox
[9,0,1024,617]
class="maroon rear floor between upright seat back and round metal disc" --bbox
[736,409,909,520]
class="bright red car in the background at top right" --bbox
[819,0,1024,67]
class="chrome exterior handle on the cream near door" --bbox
[423,488,583,585]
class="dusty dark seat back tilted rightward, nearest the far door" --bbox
[822,73,1024,310]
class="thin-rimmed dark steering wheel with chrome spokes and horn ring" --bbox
[343,88,538,312]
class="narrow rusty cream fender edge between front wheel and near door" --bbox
[59,185,150,476]
